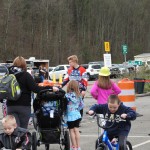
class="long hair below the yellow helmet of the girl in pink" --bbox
[97,76,112,89]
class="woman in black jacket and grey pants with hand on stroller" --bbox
[7,56,58,129]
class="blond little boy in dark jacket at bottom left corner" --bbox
[0,115,31,150]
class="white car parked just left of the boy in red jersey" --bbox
[49,64,70,80]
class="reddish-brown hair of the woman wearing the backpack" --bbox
[13,56,27,71]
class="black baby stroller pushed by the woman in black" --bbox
[32,89,70,150]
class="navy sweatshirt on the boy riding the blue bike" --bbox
[90,103,136,136]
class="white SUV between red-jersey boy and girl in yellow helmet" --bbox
[81,64,102,80]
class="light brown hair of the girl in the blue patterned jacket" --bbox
[67,80,81,96]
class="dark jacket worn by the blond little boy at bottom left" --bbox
[0,127,32,150]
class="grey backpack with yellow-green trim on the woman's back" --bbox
[0,74,21,101]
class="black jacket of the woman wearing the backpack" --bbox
[7,71,52,106]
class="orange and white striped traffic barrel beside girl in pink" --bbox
[118,78,136,110]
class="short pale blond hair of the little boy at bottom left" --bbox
[2,115,16,125]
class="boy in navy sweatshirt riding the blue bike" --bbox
[88,95,136,150]
